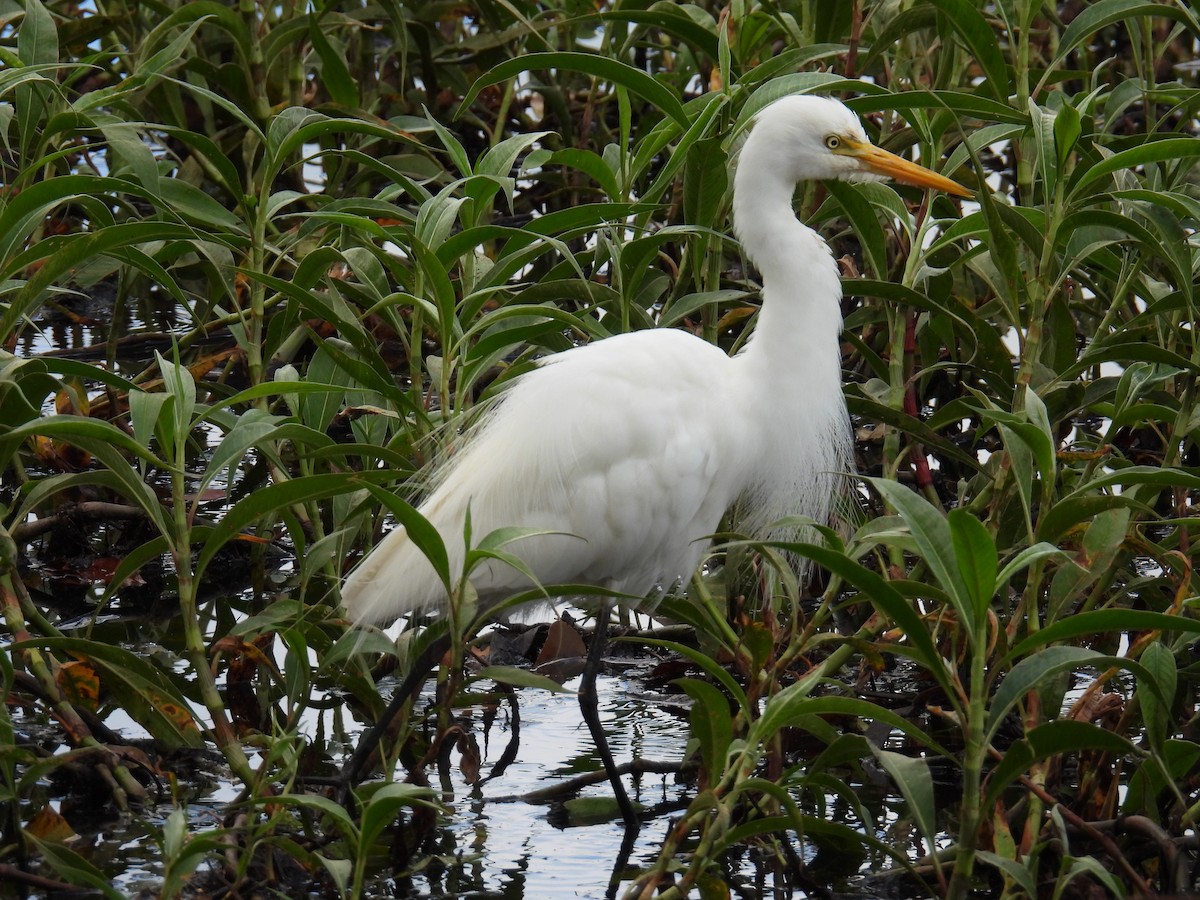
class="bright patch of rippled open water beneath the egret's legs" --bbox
[362,676,688,900]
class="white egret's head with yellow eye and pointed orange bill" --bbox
[746,95,971,197]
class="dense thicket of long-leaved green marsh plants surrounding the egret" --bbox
[0,0,1200,898]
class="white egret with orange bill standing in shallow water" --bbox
[342,96,970,821]
